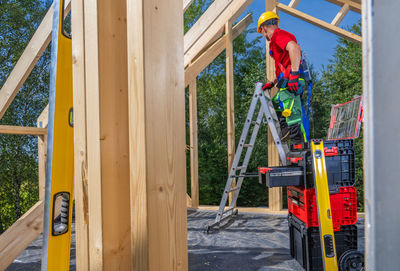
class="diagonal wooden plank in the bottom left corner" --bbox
[0,201,44,270]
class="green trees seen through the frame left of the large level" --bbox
[0,0,49,233]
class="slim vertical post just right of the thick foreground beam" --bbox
[189,79,199,208]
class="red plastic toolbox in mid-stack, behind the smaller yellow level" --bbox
[287,186,357,231]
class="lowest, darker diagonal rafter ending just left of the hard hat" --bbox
[185,14,253,86]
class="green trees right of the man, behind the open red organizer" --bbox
[310,23,364,210]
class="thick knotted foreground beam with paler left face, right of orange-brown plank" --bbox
[127,0,188,271]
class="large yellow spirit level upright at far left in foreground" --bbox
[42,0,74,271]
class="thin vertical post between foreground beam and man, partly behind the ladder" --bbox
[225,21,236,204]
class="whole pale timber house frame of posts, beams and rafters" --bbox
[0,0,362,270]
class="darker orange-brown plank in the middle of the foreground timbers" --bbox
[95,0,131,270]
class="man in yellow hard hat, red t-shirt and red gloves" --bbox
[257,11,308,144]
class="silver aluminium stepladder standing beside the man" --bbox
[207,83,288,232]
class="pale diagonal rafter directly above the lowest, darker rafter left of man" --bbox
[184,0,253,67]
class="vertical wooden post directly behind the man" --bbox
[265,0,282,211]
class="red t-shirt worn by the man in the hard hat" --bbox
[269,28,297,78]
